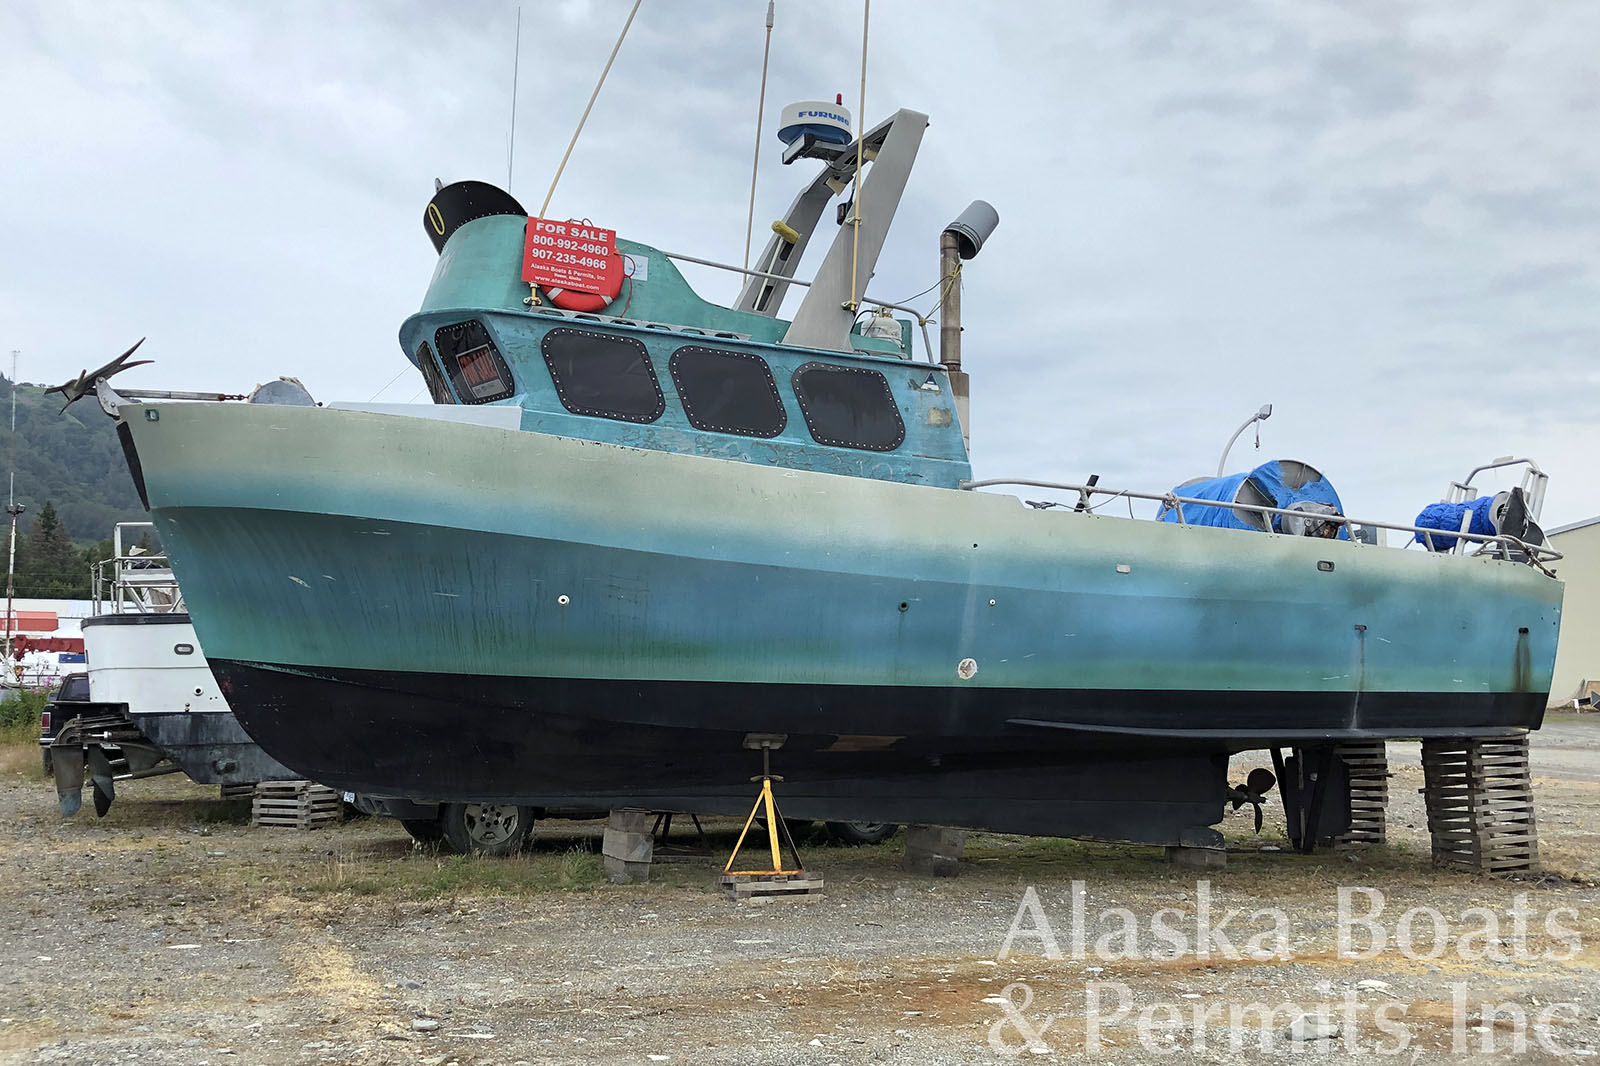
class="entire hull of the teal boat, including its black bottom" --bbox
[125,405,1562,842]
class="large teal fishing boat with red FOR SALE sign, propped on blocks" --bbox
[78,104,1562,845]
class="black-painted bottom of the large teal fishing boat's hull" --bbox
[211,659,1544,844]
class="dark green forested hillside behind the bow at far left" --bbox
[0,376,149,597]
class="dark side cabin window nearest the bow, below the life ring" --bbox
[539,330,667,423]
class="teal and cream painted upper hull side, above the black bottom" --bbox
[131,407,1562,698]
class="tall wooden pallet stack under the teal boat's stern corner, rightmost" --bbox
[1422,736,1539,874]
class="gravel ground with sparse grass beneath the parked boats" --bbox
[0,717,1600,1066]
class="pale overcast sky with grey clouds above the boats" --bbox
[0,0,1600,527]
